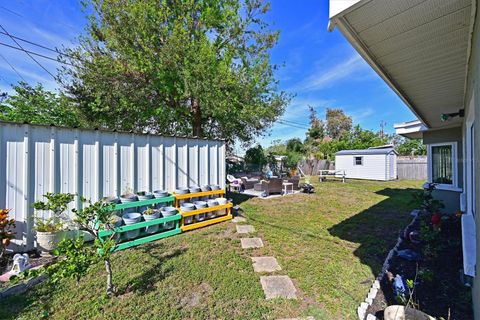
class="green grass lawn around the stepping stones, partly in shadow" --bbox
[0,181,421,319]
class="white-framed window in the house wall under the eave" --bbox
[428,142,457,188]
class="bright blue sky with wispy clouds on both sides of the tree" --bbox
[0,0,415,152]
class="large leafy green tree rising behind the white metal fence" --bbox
[63,0,290,142]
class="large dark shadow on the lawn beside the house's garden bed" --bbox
[328,188,418,275]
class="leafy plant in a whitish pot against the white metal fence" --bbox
[33,192,75,252]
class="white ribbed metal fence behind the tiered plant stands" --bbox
[0,122,225,251]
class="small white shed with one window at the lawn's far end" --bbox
[335,147,398,181]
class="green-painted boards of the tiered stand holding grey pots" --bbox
[98,196,182,251]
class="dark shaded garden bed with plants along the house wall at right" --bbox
[367,216,473,320]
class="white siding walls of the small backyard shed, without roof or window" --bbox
[335,154,389,180]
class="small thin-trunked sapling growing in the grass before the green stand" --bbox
[73,198,116,295]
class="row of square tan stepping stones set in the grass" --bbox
[232,216,297,299]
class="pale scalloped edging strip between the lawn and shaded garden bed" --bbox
[357,209,420,320]
